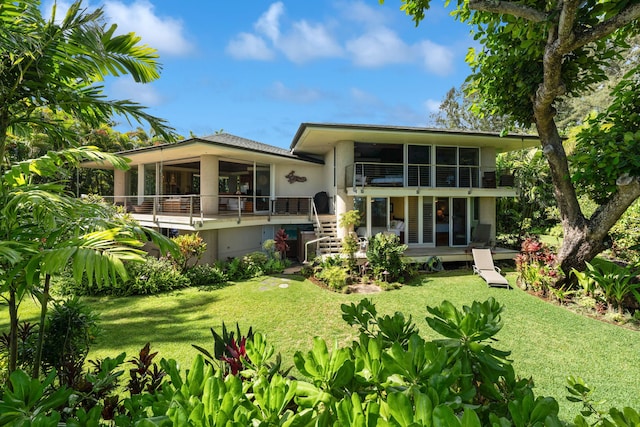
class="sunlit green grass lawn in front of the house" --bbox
[0,270,640,419]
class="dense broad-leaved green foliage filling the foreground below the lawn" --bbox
[0,298,640,427]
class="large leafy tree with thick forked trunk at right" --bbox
[384,0,640,278]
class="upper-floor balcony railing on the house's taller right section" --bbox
[345,162,514,188]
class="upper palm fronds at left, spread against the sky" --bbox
[0,0,175,164]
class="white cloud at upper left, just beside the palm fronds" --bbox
[104,0,193,56]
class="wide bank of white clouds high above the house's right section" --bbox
[226,1,454,75]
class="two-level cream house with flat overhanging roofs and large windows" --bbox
[88,123,539,262]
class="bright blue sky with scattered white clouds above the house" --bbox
[44,0,474,148]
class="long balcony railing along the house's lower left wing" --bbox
[103,194,313,223]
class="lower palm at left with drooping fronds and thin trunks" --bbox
[0,148,175,377]
